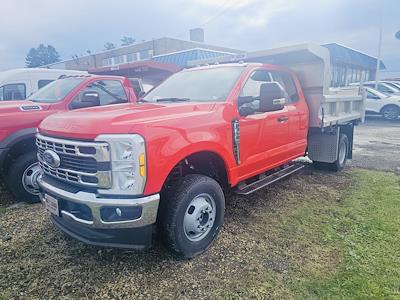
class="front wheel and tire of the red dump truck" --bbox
[158,174,225,258]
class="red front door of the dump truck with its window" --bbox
[238,69,289,180]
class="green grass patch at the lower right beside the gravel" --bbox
[295,171,400,299]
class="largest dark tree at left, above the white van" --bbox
[25,44,60,68]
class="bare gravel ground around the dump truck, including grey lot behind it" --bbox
[0,119,400,299]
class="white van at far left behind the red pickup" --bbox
[0,68,88,101]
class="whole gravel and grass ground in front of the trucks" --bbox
[0,168,400,299]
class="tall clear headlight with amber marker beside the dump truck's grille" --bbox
[96,134,147,195]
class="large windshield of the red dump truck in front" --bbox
[142,66,244,102]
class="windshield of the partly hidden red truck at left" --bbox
[28,77,84,103]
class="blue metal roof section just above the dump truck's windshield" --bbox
[152,48,234,67]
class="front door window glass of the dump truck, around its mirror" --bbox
[238,70,271,116]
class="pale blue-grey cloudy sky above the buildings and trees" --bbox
[0,0,400,73]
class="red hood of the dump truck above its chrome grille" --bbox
[39,103,215,140]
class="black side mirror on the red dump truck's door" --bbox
[260,82,287,112]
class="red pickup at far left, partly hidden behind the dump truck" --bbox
[0,75,141,202]
